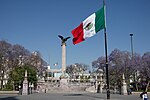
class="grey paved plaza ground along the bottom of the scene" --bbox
[0,92,142,100]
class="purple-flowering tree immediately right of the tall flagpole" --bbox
[109,49,134,88]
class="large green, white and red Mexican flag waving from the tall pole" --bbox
[72,6,105,44]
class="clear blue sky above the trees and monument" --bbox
[0,0,150,68]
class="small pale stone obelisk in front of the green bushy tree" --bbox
[22,70,28,95]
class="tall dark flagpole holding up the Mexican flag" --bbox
[103,0,110,99]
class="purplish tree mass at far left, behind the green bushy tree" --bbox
[0,40,47,88]
